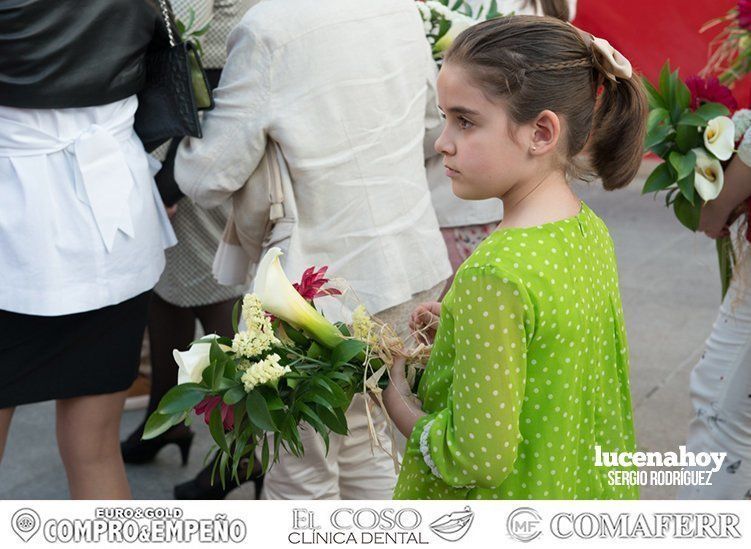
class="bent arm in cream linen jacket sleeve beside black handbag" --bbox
[175,21,272,208]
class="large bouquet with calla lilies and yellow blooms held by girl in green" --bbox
[143,248,426,485]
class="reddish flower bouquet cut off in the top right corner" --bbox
[701,0,751,86]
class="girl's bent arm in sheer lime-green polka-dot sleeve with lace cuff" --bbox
[396,267,534,488]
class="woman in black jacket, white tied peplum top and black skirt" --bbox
[0,0,175,499]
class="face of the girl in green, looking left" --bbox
[435,63,536,200]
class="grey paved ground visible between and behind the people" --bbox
[0,161,720,499]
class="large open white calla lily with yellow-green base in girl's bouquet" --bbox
[253,248,344,349]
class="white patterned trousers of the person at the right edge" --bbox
[678,250,751,499]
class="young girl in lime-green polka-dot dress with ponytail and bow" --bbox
[384,16,647,499]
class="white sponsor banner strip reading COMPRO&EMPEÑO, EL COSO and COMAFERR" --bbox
[0,500,751,549]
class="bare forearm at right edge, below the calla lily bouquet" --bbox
[699,155,751,238]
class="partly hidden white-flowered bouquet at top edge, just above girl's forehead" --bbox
[416,0,502,65]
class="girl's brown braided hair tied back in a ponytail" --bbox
[444,15,647,190]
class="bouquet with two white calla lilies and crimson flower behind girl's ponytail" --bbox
[642,62,737,297]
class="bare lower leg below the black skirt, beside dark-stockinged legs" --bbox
[57,391,132,499]
